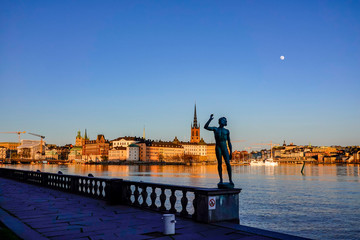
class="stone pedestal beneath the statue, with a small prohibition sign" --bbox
[194,188,241,223]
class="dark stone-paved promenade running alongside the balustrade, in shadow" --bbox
[0,178,308,240]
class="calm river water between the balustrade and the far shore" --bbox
[0,164,360,239]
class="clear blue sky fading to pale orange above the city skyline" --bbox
[0,0,360,150]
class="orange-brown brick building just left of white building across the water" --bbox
[82,134,110,161]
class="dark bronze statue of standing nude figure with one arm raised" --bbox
[204,114,234,188]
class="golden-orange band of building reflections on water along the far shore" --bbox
[0,164,360,182]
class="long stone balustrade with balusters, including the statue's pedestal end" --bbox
[0,168,241,222]
